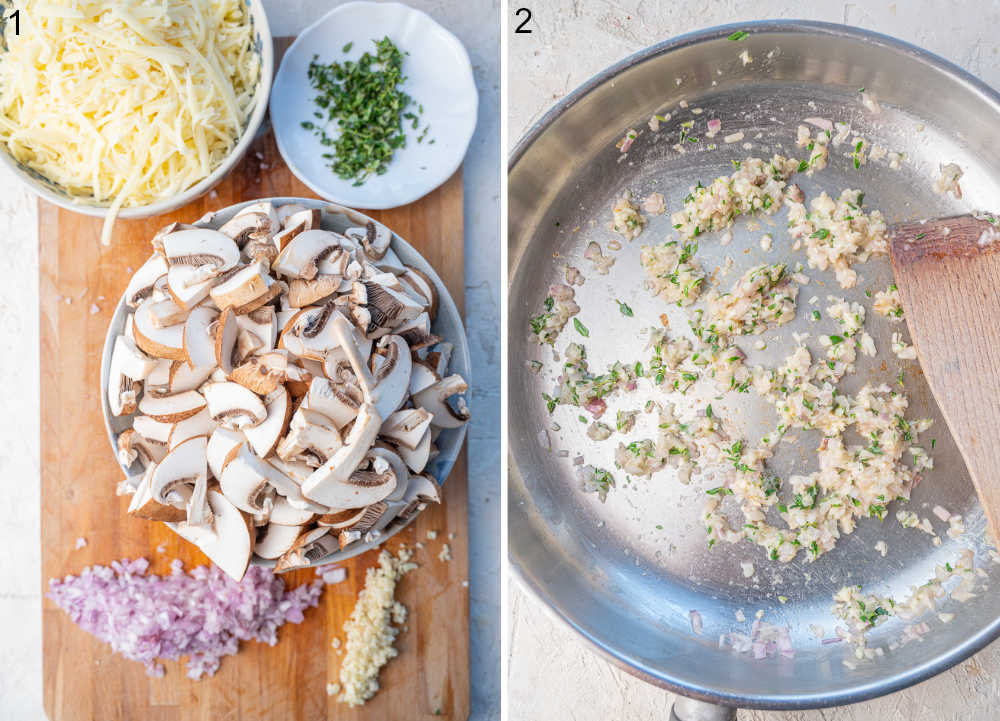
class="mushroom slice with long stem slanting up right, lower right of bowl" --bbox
[302,403,384,508]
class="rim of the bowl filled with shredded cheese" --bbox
[0,0,274,220]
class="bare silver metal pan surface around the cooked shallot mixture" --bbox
[508,22,1000,708]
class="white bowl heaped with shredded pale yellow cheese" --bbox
[0,0,274,244]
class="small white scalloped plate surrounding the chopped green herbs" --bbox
[270,2,479,208]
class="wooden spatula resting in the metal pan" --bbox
[889,215,1000,539]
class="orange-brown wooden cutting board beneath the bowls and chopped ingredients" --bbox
[38,124,469,721]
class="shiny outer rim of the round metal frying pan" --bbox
[507,19,1000,710]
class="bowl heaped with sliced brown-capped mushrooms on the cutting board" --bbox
[101,198,469,579]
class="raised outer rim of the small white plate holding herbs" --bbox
[268,0,479,210]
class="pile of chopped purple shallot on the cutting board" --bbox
[47,558,324,680]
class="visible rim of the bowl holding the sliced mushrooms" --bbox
[99,196,472,570]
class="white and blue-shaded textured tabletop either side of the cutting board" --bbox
[0,0,500,721]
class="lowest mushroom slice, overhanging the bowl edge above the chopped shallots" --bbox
[167,490,254,581]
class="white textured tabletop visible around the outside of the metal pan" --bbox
[507,0,1000,721]
